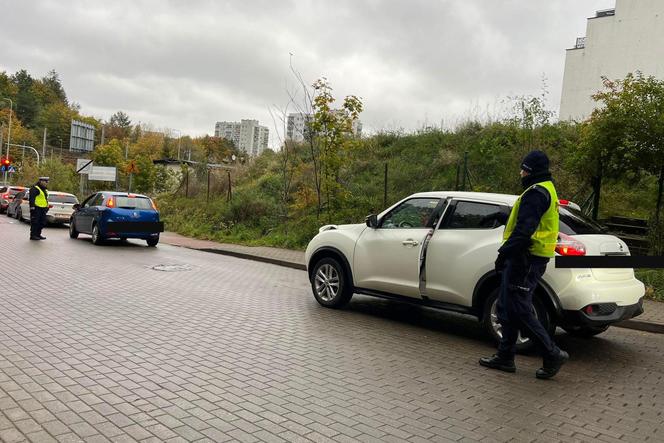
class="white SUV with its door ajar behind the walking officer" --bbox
[305,192,645,349]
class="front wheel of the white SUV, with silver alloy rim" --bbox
[311,257,353,308]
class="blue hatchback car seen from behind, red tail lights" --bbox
[69,192,164,246]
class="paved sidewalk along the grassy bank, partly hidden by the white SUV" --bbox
[161,232,664,334]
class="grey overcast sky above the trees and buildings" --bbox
[0,0,615,146]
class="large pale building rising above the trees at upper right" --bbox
[560,0,664,121]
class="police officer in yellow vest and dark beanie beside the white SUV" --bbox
[480,151,569,379]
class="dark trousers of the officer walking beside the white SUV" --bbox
[496,257,559,359]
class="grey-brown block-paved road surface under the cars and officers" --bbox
[0,216,664,442]
